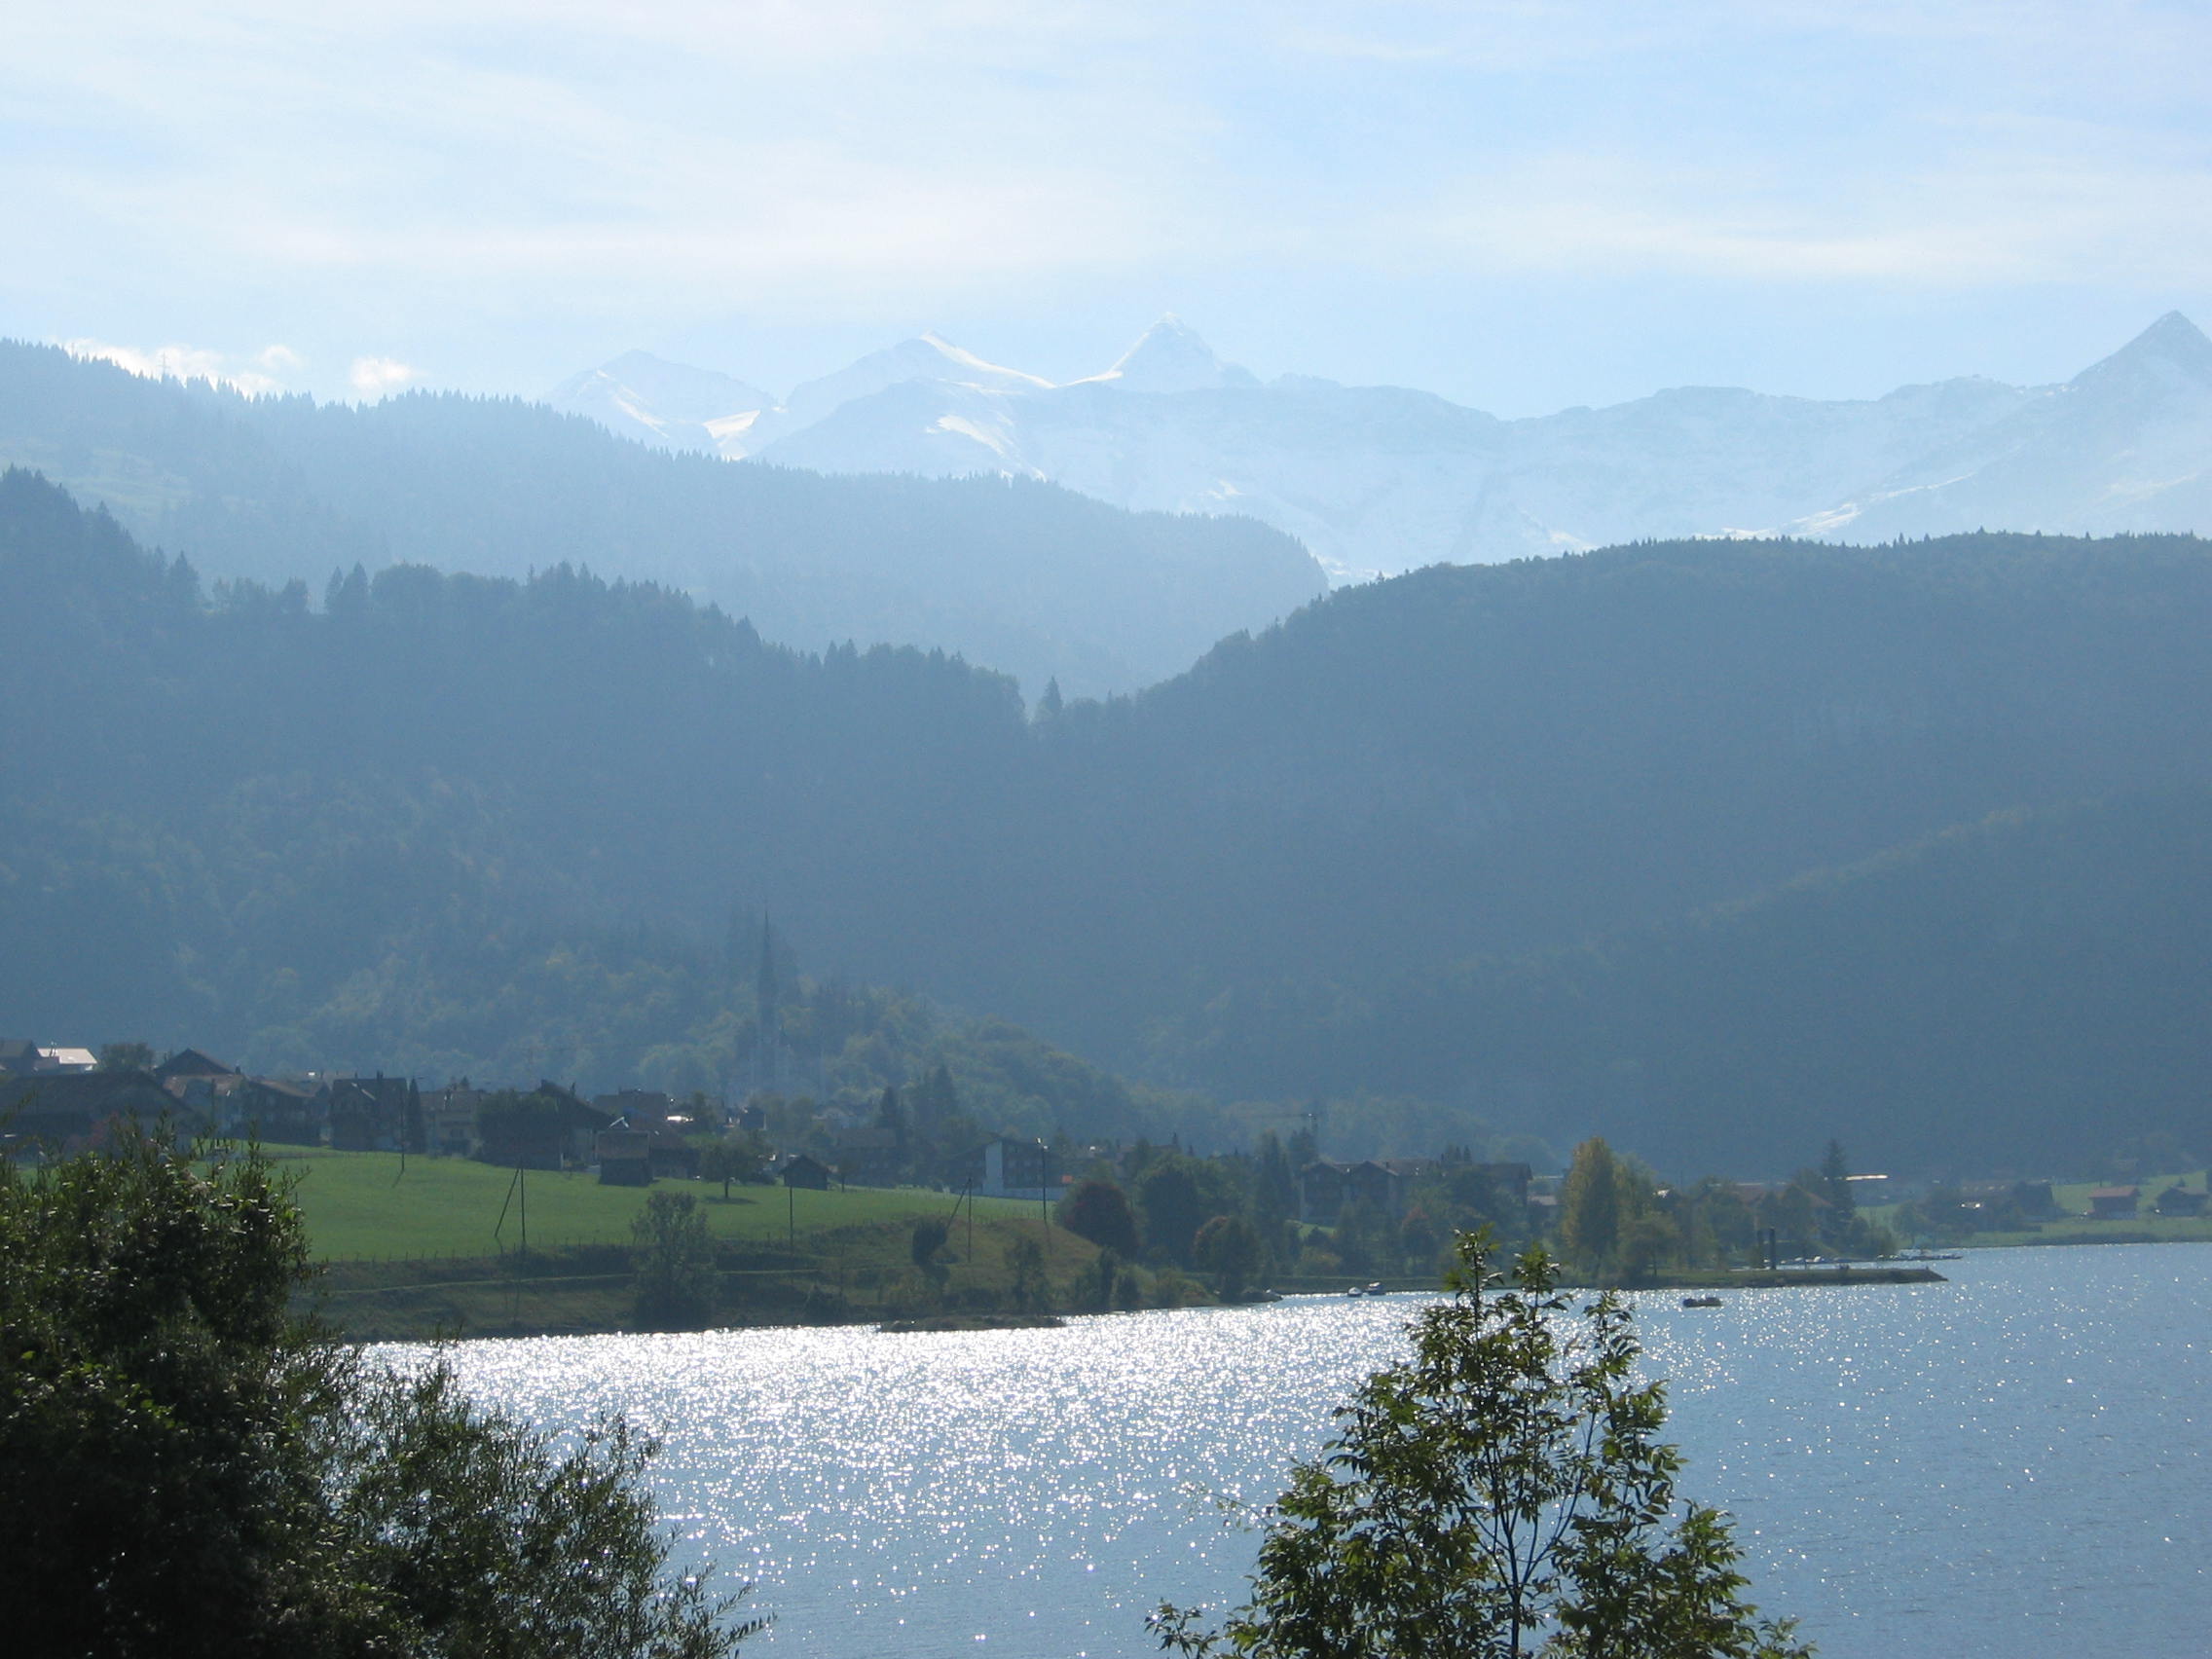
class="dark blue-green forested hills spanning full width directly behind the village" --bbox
[0,473,2212,1172]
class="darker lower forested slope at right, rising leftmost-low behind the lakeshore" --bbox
[1155,790,2212,1174]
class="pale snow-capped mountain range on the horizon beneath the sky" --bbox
[548,312,2212,579]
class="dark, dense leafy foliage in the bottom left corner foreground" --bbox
[0,1132,746,1659]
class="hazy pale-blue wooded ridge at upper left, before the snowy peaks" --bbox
[0,345,1323,692]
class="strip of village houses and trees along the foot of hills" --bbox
[0,1040,2207,1278]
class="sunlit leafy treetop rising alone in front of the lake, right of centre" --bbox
[1153,1236,1809,1659]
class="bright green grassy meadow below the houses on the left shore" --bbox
[268,1148,1038,1261]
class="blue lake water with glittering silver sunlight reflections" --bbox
[416,1245,2212,1659]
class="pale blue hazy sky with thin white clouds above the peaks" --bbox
[0,0,2212,414]
